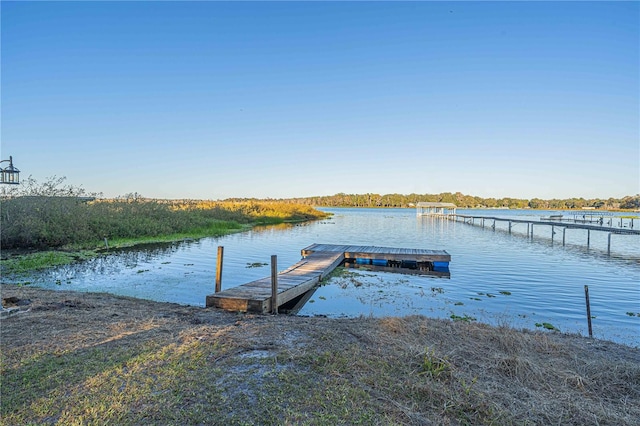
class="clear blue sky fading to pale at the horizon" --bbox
[0,1,640,199]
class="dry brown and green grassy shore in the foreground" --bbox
[0,285,640,425]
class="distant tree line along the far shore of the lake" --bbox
[278,192,640,210]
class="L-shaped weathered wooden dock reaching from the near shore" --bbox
[206,244,451,313]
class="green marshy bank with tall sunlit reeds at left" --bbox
[0,197,326,272]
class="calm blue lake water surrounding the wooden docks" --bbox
[3,208,640,346]
